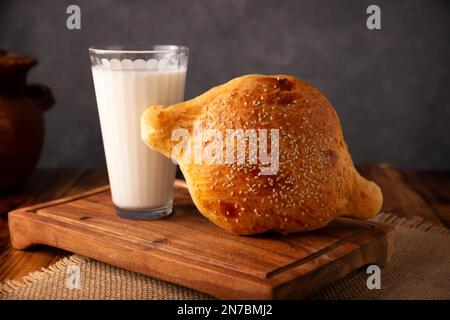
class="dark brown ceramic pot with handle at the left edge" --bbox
[0,50,54,191]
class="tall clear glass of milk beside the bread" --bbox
[89,45,189,219]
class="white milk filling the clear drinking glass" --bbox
[92,59,186,210]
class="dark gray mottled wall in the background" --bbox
[0,0,450,168]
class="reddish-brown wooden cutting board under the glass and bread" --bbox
[9,181,393,299]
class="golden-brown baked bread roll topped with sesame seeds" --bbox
[141,75,383,235]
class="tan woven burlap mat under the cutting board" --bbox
[0,214,450,299]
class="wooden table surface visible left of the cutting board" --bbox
[0,169,108,281]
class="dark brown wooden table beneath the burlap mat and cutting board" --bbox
[0,164,450,281]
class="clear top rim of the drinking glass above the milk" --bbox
[89,44,189,54]
